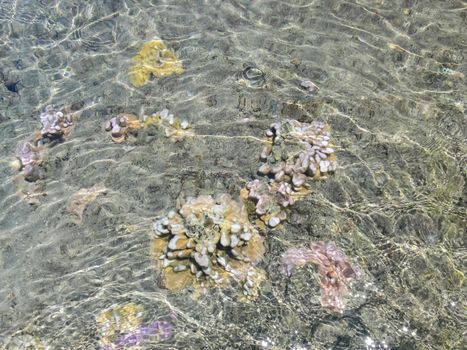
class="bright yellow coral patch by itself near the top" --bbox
[129,40,183,87]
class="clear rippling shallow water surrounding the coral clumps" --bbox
[0,0,467,349]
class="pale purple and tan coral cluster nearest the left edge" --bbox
[12,105,79,182]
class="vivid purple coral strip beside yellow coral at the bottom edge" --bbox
[103,321,174,350]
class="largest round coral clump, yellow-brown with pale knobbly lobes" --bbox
[154,194,264,294]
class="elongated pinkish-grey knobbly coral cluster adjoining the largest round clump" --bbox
[247,120,337,227]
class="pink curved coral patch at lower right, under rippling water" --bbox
[281,242,358,312]
